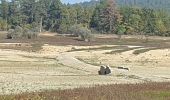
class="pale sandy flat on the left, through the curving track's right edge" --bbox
[0,47,142,94]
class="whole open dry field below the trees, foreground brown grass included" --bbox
[0,32,170,100]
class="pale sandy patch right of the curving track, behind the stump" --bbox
[77,49,170,82]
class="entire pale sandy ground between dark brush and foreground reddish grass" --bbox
[0,44,170,94]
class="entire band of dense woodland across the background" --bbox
[0,0,170,38]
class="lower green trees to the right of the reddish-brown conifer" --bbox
[120,7,170,36]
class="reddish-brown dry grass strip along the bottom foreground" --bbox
[0,83,170,100]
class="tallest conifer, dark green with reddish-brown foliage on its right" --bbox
[91,0,117,33]
